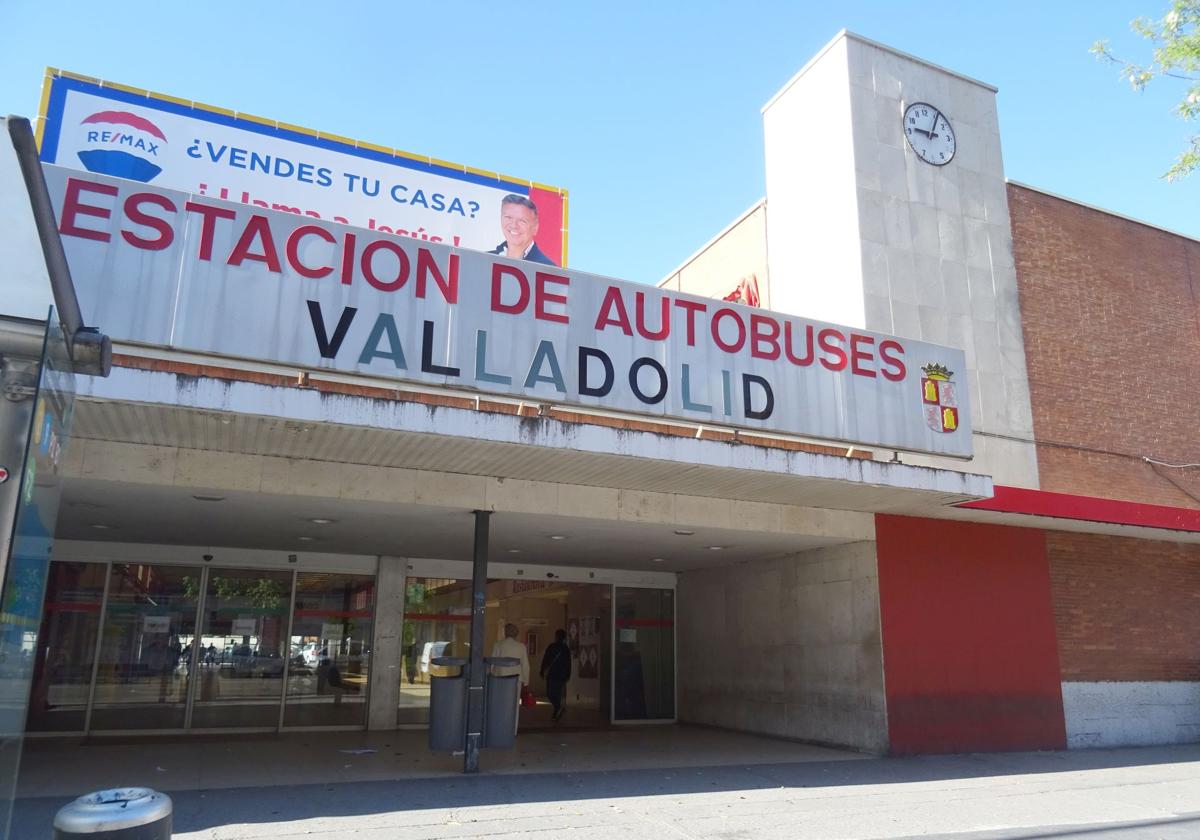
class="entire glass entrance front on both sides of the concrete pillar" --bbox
[26,560,674,734]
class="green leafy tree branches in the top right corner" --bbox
[1092,0,1200,181]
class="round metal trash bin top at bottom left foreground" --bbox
[54,787,172,840]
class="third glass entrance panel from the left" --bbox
[190,569,292,730]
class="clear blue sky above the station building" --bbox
[0,0,1200,282]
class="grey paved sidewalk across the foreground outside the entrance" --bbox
[13,745,1200,840]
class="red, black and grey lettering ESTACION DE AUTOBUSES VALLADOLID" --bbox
[60,176,907,419]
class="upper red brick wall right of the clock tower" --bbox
[1008,184,1200,508]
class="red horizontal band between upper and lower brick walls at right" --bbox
[956,486,1200,533]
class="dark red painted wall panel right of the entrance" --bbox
[875,515,1067,755]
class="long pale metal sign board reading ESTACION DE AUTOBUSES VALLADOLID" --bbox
[44,166,971,457]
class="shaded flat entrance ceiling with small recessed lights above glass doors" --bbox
[55,479,845,571]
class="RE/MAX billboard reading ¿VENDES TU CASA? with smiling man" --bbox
[38,70,566,265]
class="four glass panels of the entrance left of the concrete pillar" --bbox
[25,562,376,734]
